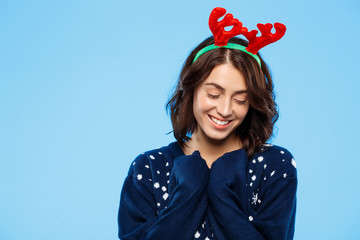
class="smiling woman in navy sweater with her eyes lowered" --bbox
[118,7,297,240]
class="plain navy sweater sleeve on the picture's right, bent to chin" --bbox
[208,150,297,240]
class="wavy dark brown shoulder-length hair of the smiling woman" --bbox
[166,37,279,157]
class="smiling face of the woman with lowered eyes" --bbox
[193,64,249,141]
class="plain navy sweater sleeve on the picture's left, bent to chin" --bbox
[118,153,209,240]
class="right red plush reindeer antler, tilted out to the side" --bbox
[243,23,286,54]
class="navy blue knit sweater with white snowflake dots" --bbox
[118,142,297,240]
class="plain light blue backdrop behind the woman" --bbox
[0,0,360,240]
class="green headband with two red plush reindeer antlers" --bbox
[193,7,286,66]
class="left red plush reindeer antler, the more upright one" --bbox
[209,7,248,46]
